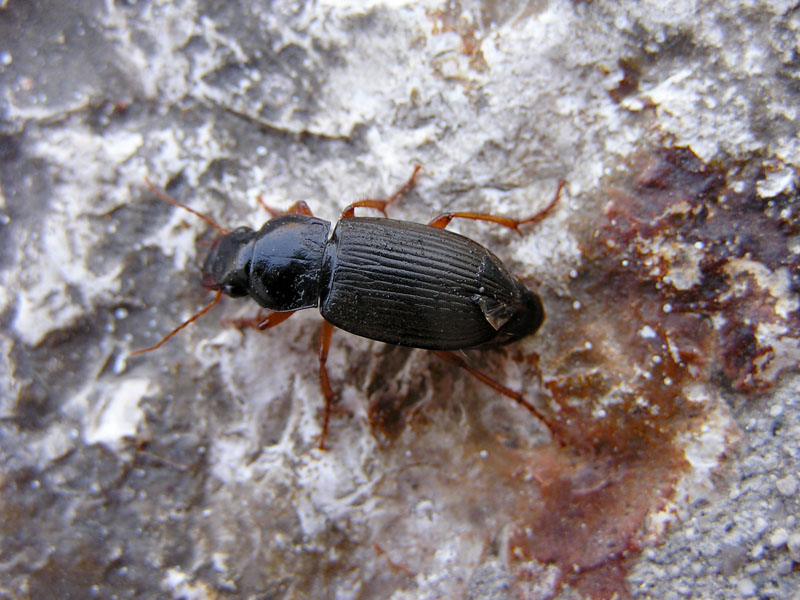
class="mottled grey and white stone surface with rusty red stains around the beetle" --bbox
[0,0,800,600]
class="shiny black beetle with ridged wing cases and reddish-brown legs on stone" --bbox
[133,165,565,449]
